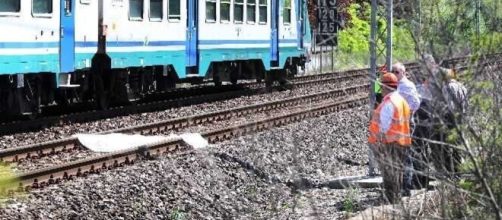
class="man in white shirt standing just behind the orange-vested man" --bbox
[392,62,423,196]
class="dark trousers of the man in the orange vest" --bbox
[373,144,407,203]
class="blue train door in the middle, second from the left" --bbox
[185,0,198,67]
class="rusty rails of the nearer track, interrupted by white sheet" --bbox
[0,92,368,190]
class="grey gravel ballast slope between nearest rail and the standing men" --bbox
[0,107,379,219]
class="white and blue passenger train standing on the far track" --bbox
[0,0,311,115]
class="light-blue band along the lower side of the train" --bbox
[0,41,303,75]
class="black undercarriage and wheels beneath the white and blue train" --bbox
[0,55,301,118]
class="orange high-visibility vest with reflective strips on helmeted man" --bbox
[368,93,411,147]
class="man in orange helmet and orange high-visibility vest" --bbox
[368,73,411,203]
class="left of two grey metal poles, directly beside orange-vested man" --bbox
[368,0,378,176]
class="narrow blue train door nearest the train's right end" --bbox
[270,0,279,67]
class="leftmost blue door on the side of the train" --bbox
[59,0,75,73]
